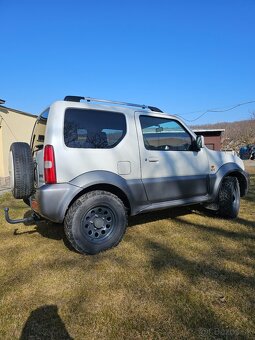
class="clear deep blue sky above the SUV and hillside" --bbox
[0,0,255,124]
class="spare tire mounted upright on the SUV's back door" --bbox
[9,142,34,199]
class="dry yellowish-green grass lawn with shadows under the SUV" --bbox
[0,167,255,340]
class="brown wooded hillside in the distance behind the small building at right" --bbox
[191,119,255,151]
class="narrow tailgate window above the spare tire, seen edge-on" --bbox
[31,109,49,152]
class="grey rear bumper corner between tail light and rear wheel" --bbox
[30,183,81,223]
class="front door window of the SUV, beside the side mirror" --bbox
[140,116,192,151]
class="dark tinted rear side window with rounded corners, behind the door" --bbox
[64,108,126,149]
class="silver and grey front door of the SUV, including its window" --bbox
[135,112,209,203]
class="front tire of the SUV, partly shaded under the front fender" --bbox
[218,177,240,218]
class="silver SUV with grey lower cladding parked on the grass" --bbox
[5,96,249,254]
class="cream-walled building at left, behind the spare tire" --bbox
[0,101,36,185]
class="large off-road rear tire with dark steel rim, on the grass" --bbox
[64,190,127,255]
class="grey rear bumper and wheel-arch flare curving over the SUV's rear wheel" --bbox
[35,171,146,223]
